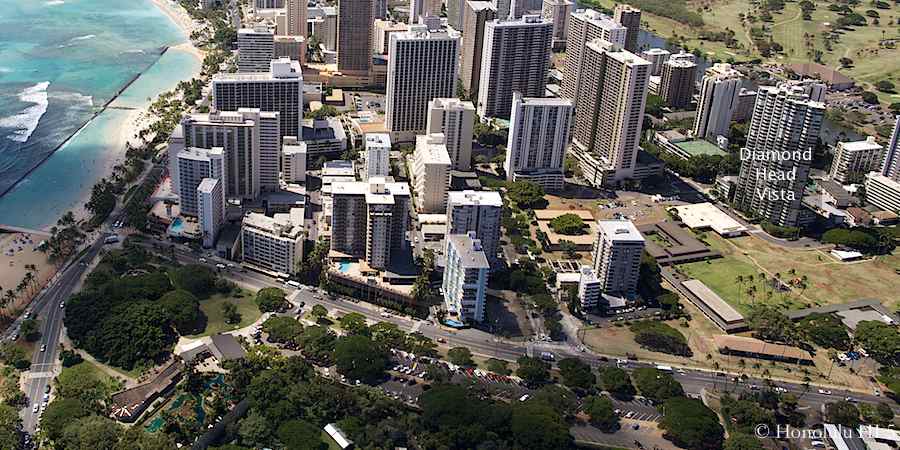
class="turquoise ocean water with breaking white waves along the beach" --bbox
[0,0,200,228]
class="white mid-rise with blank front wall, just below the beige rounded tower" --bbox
[412,134,450,214]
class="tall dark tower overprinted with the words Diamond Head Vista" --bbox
[734,83,825,227]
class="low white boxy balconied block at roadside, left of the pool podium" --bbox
[241,208,306,275]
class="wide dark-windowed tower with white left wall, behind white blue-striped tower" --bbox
[476,15,553,119]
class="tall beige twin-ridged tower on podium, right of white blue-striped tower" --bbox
[572,39,650,186]
